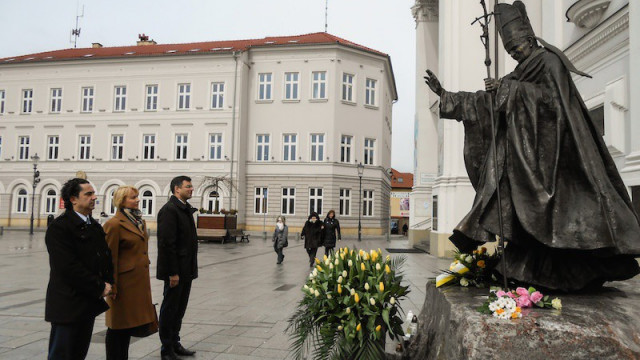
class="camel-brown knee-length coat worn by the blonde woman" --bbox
[104,211,156,329]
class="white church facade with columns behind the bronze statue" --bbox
[410,0,640,256]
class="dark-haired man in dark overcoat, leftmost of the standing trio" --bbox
[44,178,113,360]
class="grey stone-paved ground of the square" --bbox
[0,230,449,360]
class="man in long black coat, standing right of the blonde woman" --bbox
[156,176,198,360]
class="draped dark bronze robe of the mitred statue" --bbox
[440,48,640,291]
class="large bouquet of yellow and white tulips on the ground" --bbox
[287,247,409,360]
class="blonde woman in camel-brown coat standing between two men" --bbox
[104,186,158,360]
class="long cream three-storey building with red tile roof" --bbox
[0,33,397,234]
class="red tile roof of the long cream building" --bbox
[0,32,388,65]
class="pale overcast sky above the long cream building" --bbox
[0,0,416,172]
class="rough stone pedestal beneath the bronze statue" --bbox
[398,278,640,360]
